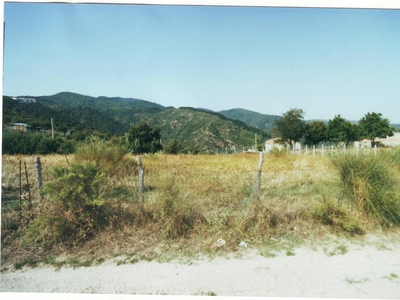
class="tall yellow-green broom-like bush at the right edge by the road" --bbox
[332,153,400,225]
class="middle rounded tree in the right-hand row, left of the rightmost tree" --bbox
[326,115,359,146]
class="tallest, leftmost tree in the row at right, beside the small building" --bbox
[274,108,305,147]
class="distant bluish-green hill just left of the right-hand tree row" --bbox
[219,108,281,133]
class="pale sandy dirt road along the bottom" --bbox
[1,237,400,299]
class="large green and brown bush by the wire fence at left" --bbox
[23,138,139,249]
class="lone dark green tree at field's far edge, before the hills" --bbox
[127,121,162,154]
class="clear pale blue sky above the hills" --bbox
[3,3,400,123]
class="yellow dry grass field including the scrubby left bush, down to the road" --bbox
[1,146,400,268]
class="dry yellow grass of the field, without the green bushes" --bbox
[2,146,399,266]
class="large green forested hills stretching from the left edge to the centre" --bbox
[3,92,268,149]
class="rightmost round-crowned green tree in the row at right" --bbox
[358,112,395,146]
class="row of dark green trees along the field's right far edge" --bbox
[273,108,395,147]
